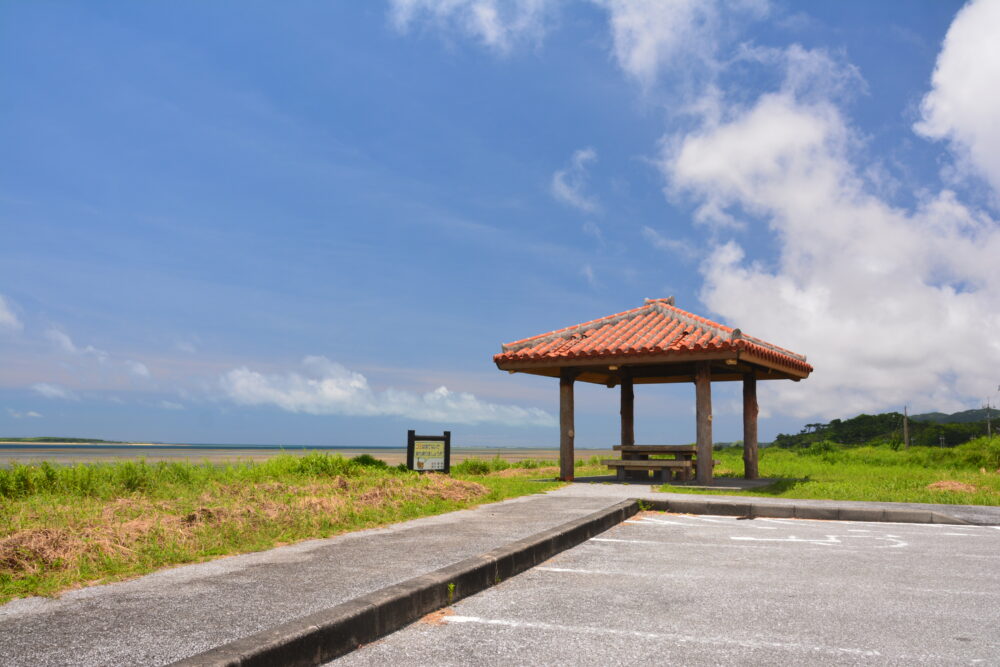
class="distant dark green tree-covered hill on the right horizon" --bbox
[773,410,1000,447]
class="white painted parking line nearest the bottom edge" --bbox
[441,616,884,658]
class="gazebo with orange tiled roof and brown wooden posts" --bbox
[493,297,812,484]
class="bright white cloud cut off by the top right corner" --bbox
[915,0,1000,201]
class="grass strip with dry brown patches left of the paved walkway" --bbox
[0,453,560,603]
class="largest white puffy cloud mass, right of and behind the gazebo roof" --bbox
[664,81,1000,417]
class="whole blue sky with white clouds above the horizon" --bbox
[0,0,1000,446]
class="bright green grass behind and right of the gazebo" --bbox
[660,437,1000,505]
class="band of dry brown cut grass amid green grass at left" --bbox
[0,475,490,576]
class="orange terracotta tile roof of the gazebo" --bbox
[493,297,812,375]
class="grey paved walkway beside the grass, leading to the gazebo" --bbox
[0,483,1000,666]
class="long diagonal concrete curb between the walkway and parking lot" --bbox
[173,500,639,667]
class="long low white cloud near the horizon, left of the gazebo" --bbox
[220,357,556,426]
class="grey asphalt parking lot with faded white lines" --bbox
[330,512,1000,666]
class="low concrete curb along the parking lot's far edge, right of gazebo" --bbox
[641,499,974,525]
